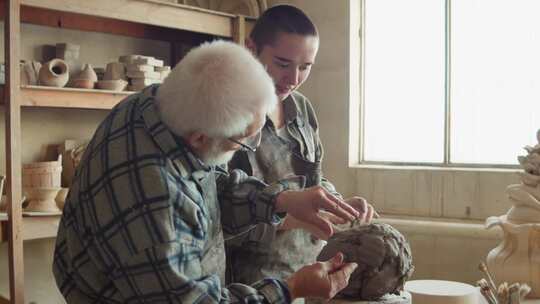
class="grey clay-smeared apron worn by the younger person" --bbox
[228,124,324,284]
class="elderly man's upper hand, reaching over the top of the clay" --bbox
[276,186,359,240]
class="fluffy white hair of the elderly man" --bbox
[156,41,277,137]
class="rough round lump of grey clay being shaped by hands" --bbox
[317,223,414,300]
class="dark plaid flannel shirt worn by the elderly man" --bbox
[53,85,290,304]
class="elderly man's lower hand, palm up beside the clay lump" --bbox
[287,253,358,300]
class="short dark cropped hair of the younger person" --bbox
[249,5,319,52]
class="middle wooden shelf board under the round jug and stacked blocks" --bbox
[0,86,135,110]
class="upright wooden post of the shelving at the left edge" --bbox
[4,0,24,304]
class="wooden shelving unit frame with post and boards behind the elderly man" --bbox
[0,0,253,304]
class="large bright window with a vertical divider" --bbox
[360,0,540,166]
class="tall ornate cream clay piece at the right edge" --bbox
[486,130,540,298]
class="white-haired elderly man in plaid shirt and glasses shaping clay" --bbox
[53,41,358,304]
